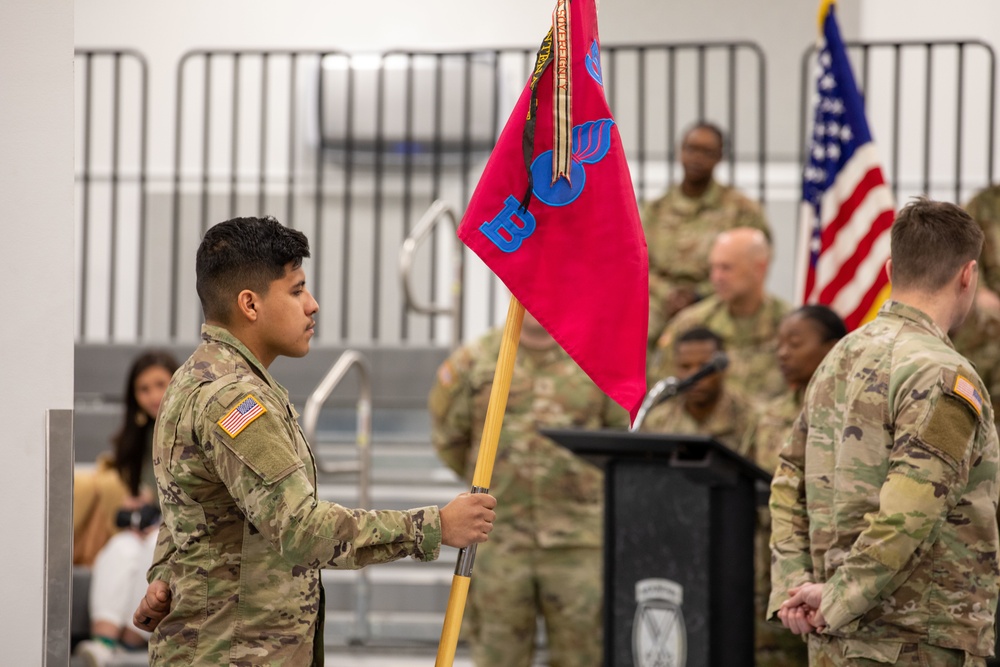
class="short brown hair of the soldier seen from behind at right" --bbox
[890,197,985,292]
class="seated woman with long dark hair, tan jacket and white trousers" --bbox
[73,351,177,666]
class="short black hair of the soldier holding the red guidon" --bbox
[195,216,309,324]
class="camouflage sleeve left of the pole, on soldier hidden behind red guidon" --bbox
[427,348,474,479]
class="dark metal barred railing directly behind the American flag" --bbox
[799,39,996,203]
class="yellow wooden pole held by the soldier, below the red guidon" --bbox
[434,296,524,667]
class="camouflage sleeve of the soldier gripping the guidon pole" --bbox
[198,385,441,569]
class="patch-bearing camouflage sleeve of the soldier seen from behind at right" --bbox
[820,367,978,631]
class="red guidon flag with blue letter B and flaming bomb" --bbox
[458,0,649,419]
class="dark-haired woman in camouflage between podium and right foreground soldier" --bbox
[753,305,847,667]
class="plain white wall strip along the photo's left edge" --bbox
[0,0,73,665]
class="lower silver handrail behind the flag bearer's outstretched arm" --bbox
[302,350,372,642]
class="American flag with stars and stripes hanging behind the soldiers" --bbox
[796,2,895,329]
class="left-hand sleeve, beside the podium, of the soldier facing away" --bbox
[766,413,813,620]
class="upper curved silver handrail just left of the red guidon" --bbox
[399,199,465,347]
